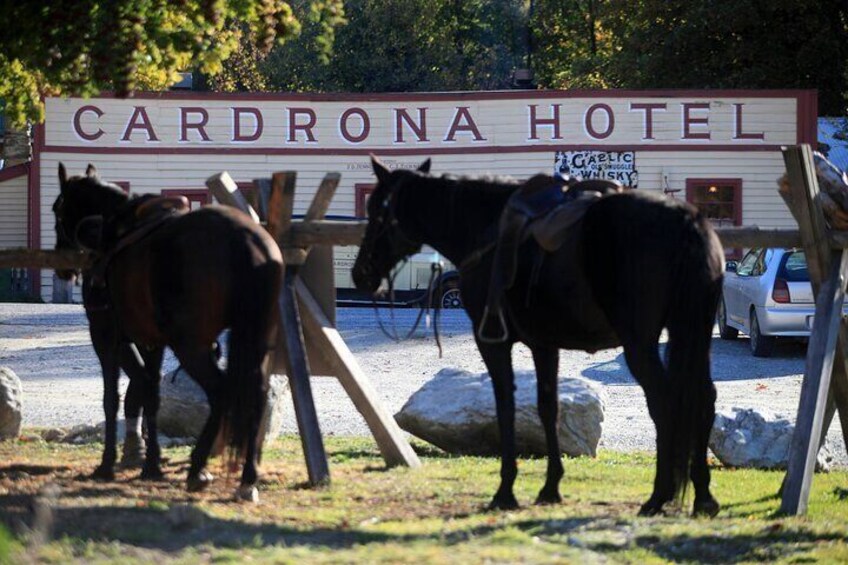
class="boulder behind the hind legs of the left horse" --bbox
[158,369,289,446]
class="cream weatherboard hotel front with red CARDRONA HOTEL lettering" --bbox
[38,91,816,296]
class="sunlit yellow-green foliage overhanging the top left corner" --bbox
[0,0,343,124]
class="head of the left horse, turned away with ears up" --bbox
[53,163,128,280]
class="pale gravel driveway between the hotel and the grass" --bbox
[0,304,848,465]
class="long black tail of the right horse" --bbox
[666,214,724,500]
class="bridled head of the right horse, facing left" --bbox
[352,155,430,292]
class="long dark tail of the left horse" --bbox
[222,254,281,468]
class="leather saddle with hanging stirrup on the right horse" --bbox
[477,175,623,343]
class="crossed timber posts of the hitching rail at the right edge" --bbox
[781,145,848,514]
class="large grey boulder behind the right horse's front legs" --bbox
[395,368,604,457]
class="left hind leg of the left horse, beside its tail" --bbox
[174,348,225,492]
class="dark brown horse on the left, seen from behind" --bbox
[53,165,282,498]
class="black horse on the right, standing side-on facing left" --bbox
[353,159,723,515]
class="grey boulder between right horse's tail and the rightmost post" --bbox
[710,408,832,469]
